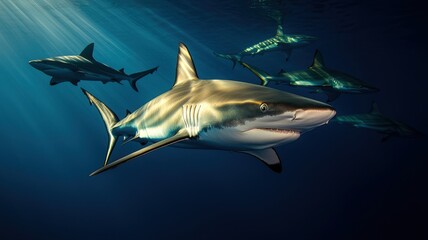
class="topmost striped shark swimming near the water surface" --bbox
[214,20,316,67]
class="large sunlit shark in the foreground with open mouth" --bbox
[82,44,336,176]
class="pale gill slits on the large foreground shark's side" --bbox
[182,104,202,137]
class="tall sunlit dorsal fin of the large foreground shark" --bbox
[174,43,199,86]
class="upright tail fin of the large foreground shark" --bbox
[81,88,119,166]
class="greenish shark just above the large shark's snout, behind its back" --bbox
[241,50,379,102]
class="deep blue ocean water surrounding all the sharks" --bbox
[0,0,428,239]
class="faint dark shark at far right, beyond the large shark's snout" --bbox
[331,102,424,142]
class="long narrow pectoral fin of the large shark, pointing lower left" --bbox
[89,129,189,176]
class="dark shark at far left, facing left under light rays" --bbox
[29,43,158,92]
